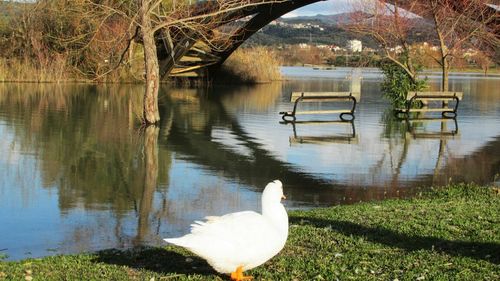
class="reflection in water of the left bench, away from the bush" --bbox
[281,120,358,144]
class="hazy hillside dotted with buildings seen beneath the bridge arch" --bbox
[247,13,433,49]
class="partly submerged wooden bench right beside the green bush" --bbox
[396,92,463,118]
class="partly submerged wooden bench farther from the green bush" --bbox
[279,92,360,122]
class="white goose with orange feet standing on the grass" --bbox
[165,180,288,281]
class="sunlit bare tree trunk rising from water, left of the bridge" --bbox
[139,0,160,124]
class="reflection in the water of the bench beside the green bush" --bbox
[405,118,459,139]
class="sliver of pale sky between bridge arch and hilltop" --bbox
[284,0,366,18]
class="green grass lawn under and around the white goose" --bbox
[0,185,500,280]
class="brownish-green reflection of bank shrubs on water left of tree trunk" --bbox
[0,84,170,218]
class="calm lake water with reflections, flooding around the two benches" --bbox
[0,67,500,260]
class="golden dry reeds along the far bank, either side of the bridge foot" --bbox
[0,47,281,84]
